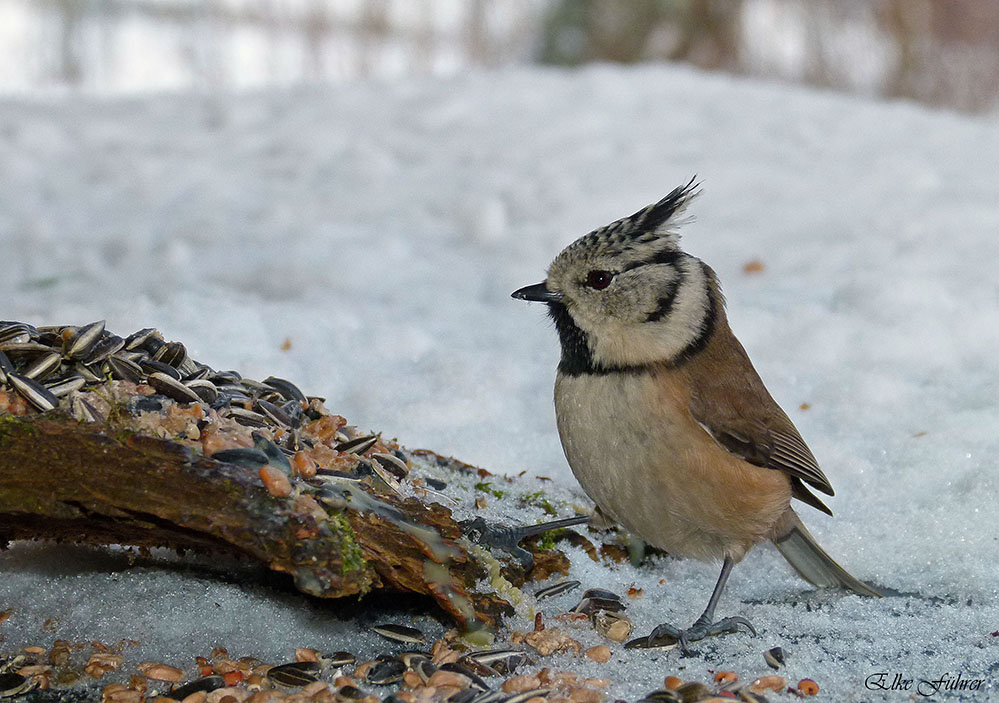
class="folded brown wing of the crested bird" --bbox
[681,306,834,515]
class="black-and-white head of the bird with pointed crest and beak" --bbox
[513,181,722,375]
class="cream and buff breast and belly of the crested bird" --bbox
[555,371,790,559]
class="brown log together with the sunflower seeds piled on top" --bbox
[0,322,512,627]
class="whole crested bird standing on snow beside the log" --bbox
[512,177,881,652]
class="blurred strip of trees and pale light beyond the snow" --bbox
[0,0,999,113]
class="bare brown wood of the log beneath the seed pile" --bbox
[0,412,522,628]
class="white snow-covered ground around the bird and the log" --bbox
[0,68,999,701]
